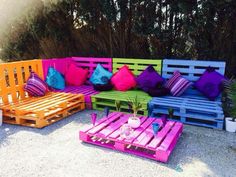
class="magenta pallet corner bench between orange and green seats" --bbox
[42,57,112,109]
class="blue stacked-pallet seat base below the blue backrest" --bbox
[148,96,224,130]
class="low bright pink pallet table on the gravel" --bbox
[79,112,183,162]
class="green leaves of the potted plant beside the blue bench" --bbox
[224,79,236,121]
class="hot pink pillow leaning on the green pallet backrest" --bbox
[111,65,136,91]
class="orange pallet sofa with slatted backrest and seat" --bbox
[0,60,85,128]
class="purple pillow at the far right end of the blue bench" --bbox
[194,67,226,101]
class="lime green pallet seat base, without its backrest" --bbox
[92,90,152,115]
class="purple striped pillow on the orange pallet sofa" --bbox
[24,72,48,97]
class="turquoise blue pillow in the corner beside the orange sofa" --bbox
[46,67,65,90]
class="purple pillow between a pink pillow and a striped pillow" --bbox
[136,65,164,92]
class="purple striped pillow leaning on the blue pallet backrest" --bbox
[165,71,192,96]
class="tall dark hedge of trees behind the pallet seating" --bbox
[0,0,236,73]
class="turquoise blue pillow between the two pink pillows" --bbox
[89,64,112,85]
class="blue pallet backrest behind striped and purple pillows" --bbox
[162,59,225,100]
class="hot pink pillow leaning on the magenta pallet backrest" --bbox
[65,63,88,86]
